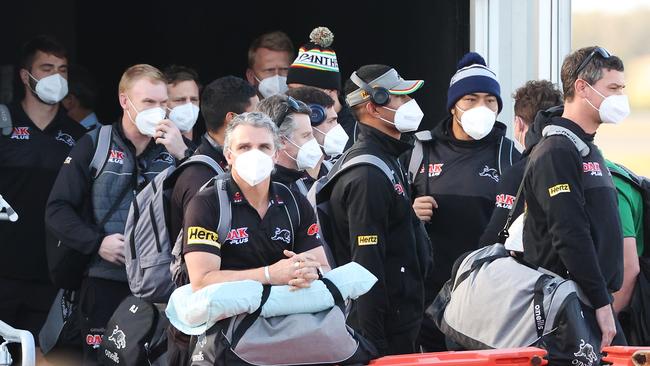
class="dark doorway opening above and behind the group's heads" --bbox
[0,0,469,128]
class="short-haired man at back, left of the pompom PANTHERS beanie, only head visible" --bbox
[246,31,294,99]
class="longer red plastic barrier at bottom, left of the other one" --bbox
[370,347,548,366]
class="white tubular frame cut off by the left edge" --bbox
[0,195,36,366]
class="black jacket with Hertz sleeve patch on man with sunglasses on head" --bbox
[524,116,623,308]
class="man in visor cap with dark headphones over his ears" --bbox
[328,65,430,354]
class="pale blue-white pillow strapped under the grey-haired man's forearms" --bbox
[165,262,377,335]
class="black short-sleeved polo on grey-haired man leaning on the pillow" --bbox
[183,177,321,270]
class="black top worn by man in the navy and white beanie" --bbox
[413,117,520,293]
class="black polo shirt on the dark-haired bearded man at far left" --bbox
[0,103,86,281]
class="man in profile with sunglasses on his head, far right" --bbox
[523,47,630,350]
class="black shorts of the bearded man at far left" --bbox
[0,278,57,346]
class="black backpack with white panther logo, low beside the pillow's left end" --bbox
[97,296,169,366]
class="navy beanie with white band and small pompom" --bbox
[447,52,503,112]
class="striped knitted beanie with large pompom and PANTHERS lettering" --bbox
[287,27,341,90]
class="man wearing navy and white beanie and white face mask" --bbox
[408,52,519,352]
